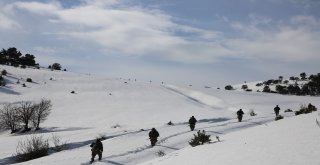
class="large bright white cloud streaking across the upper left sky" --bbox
[12,1,229,63]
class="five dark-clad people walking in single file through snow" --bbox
[90,105,280,163]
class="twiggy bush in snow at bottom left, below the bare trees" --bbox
[16,136,49,162]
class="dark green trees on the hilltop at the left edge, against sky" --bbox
[0,47,62,70]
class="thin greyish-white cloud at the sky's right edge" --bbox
[227,16,320,62]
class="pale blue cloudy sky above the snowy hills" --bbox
[0,0,320,87]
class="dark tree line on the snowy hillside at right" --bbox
[225,72,320,96]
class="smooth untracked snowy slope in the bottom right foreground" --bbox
[141,113,320,165]
